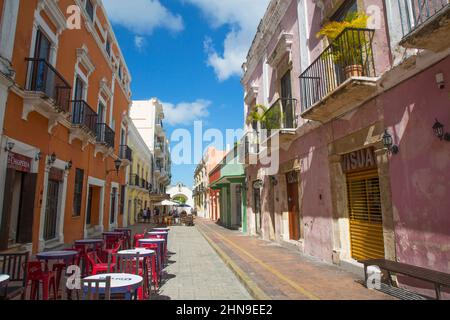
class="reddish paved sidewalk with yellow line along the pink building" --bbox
[195,218,394,300]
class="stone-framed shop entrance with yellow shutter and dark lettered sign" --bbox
[329,122,396,265]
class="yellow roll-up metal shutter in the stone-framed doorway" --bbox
[347,169,384,260]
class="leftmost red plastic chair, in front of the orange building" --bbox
[23,261,57,300]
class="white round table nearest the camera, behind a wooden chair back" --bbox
[84,273,144,298]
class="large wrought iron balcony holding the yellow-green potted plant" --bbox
[300,28,376,121]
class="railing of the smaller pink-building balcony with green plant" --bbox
[261,99,297,131]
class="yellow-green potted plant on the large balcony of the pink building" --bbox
[317,12,371,79]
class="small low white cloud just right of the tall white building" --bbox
[161,99,211,126]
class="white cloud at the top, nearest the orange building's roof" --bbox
[103,0,184,35]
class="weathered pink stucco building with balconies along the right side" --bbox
[242,0,450,293]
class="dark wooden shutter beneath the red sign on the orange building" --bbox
[17,173,37,243]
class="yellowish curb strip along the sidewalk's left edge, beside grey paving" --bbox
[196,226,272,300]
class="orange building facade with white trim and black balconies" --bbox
[0,0,132,252]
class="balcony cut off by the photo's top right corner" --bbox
[398,0,450,51]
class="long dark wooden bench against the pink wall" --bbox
[358,259,450,300]
